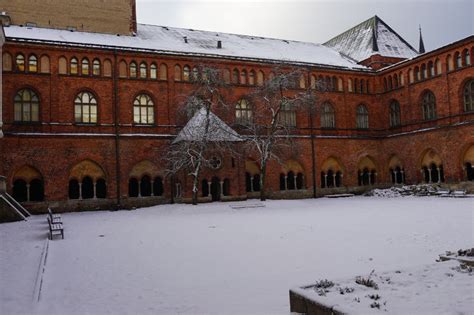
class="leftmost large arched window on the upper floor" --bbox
[13,89,39,122]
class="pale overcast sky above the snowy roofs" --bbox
[136,0,474,50]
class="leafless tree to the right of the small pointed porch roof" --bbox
[241,69,317,201]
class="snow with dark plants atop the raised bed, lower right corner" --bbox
[294,261,474,315]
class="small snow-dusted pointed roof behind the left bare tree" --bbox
[173,107,242,143]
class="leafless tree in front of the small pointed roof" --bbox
[165,67,241,205]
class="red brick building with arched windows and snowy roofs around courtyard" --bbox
[0,0,474,211]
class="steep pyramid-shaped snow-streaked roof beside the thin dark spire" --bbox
[324,16,418,62]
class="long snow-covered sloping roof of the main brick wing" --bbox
[5,24,366,69]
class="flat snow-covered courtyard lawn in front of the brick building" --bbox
[0,197,474,314]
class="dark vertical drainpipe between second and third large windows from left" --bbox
[112,49,122,210]
